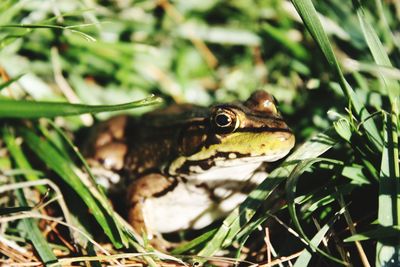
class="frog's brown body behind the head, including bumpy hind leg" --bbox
[89,104,209,176]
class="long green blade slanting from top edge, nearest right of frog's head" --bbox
[291,0,382,151]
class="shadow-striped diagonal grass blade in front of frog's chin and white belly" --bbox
[198,129,335,257]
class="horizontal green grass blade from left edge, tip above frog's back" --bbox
[0,96,162,119]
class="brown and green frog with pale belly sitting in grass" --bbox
[86,90,295,244]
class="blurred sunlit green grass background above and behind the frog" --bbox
[0,0,372,137]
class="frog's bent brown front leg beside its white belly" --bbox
[128,173,177,245]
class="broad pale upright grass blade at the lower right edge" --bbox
[376,114,400,266]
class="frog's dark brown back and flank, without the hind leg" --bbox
[125,104,209,175]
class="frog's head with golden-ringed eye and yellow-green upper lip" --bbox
[170,91,295,176]
